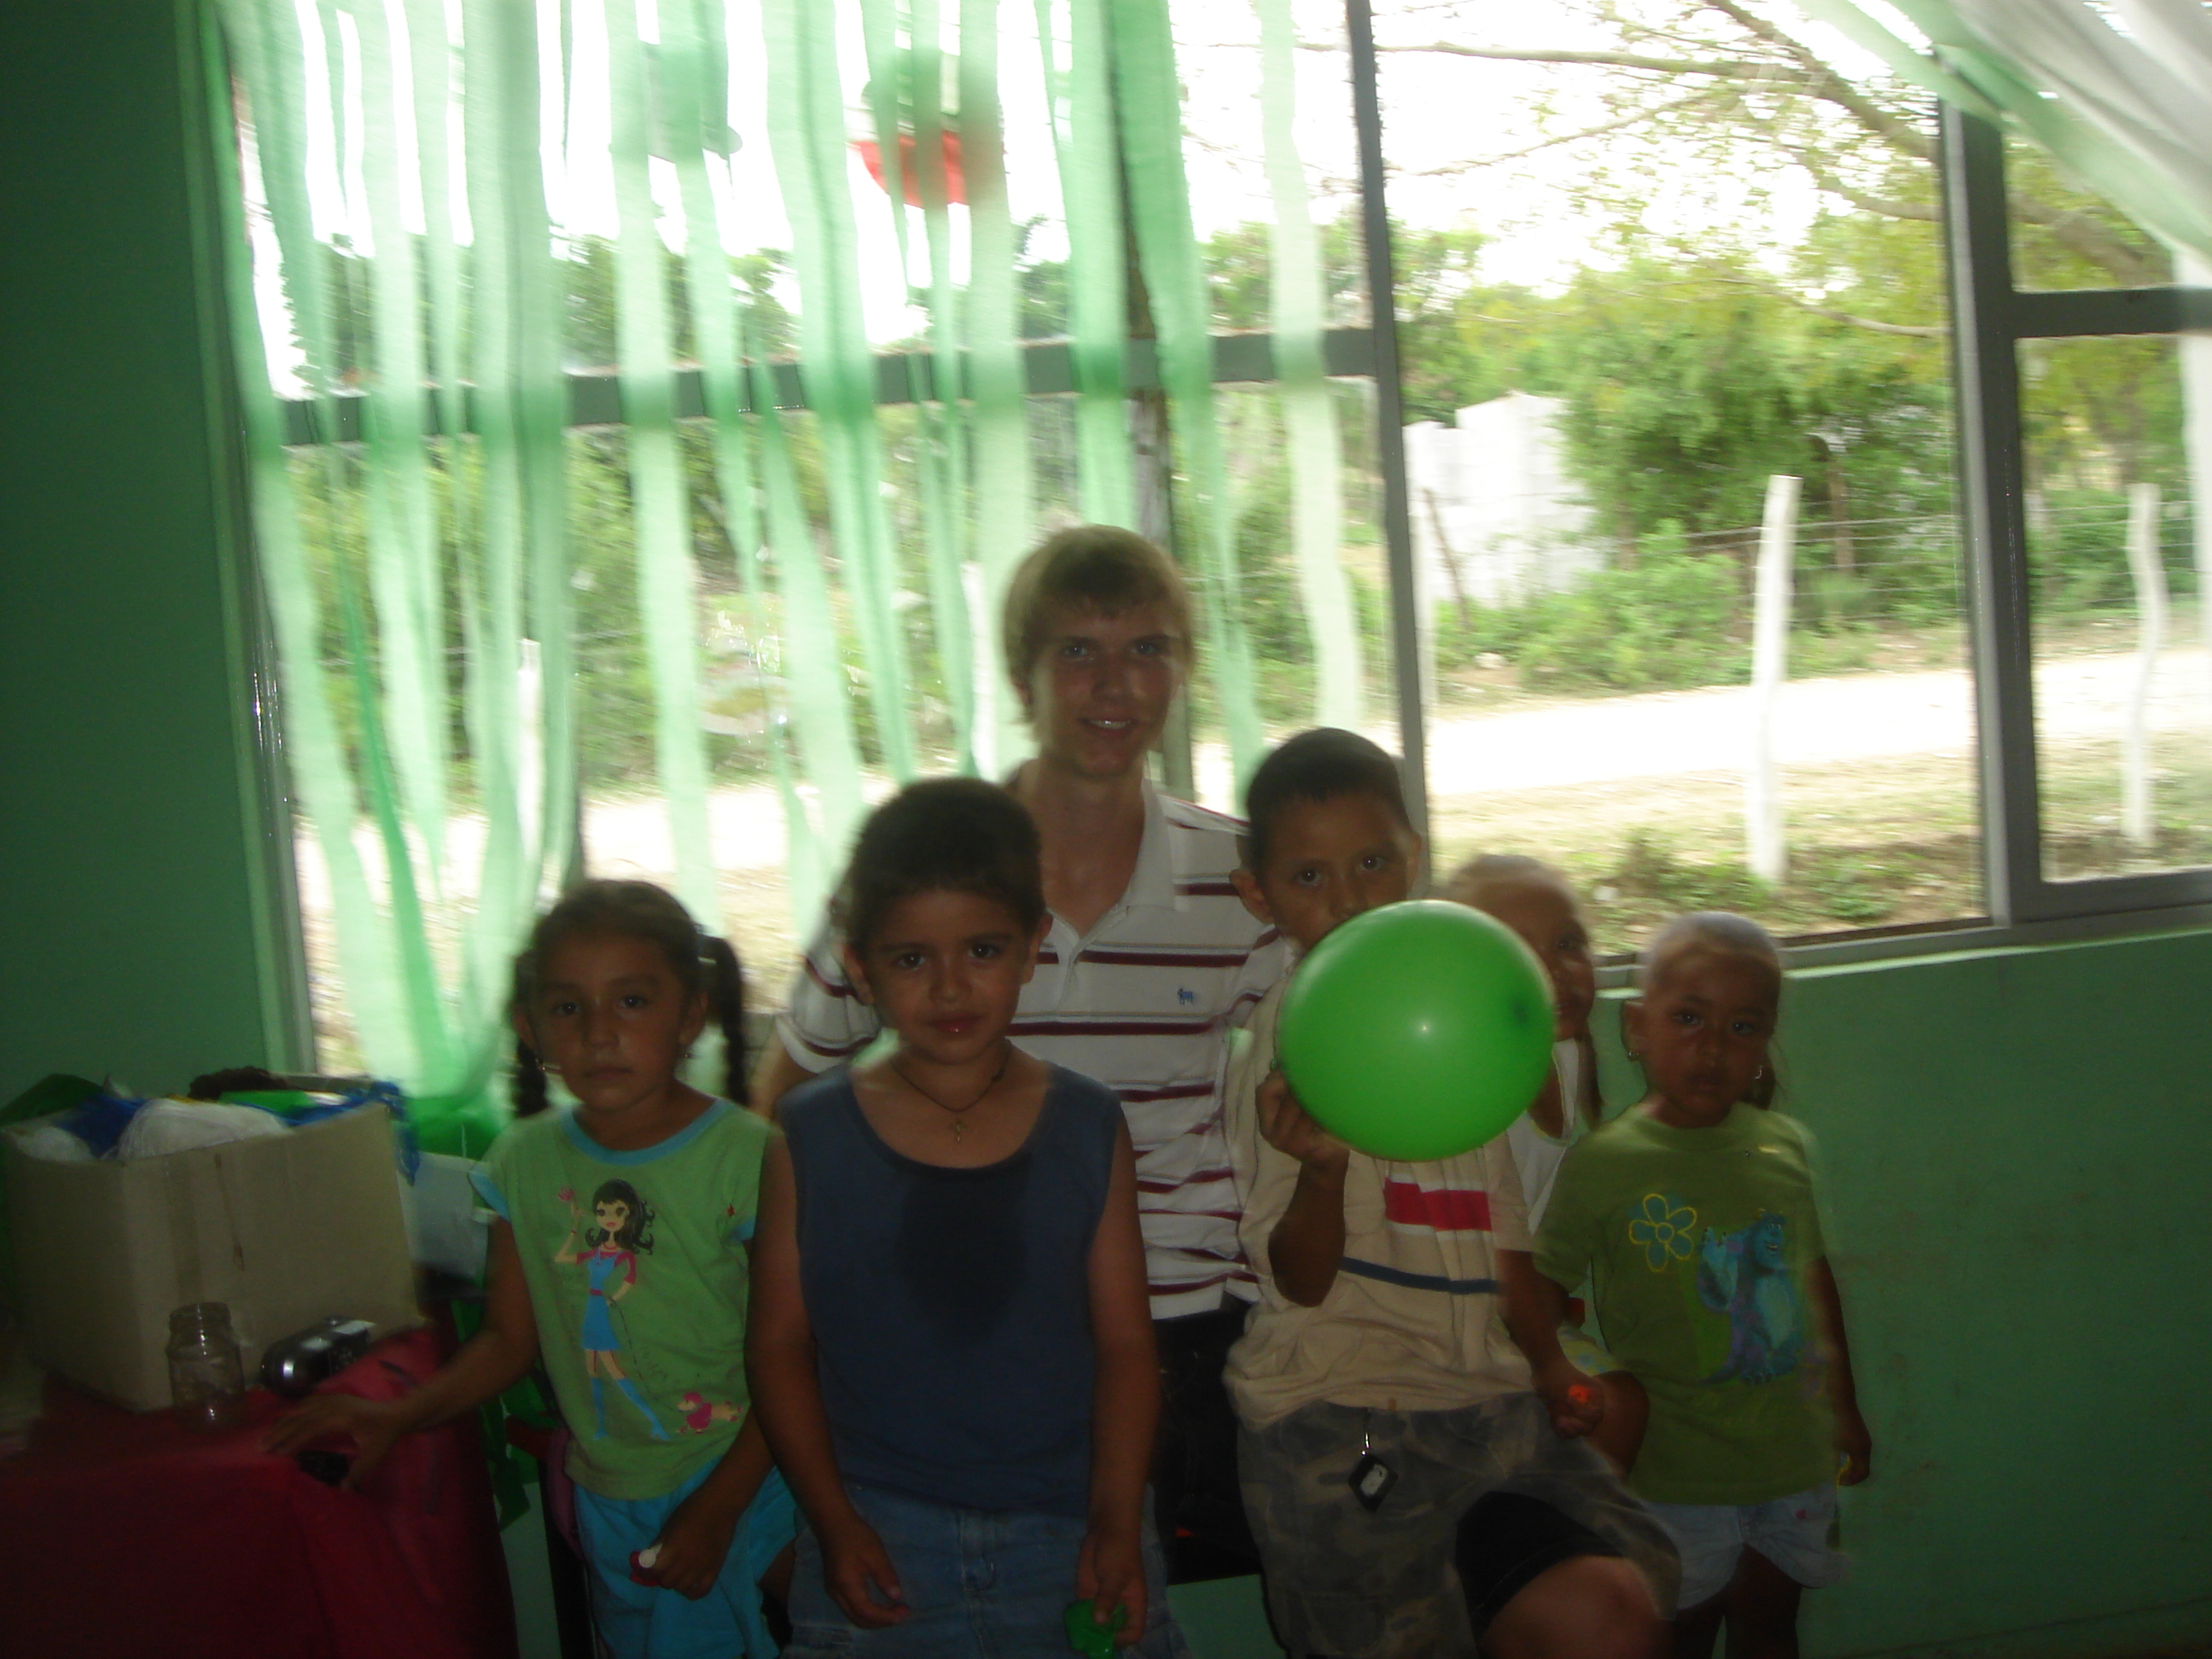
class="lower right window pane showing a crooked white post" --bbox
[2019,339,2212,881]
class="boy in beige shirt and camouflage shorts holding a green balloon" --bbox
[1223,730,1674,1659]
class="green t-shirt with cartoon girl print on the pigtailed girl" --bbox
[475,1099,774,1498]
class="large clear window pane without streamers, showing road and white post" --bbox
[1376,0,1982,952]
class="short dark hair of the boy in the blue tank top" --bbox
[834,778,1044,952]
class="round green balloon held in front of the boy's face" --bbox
[1277,898,1553,1163]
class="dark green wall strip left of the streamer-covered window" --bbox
[0,0,292,1099]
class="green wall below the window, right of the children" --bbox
[1781,934,2212,1655]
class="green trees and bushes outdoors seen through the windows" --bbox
[285,0,2194,823]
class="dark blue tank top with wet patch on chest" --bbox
[777,1066,1121,1516]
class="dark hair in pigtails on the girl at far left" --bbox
[509,881,746,1117]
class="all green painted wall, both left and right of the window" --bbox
[0,0,2212,1659]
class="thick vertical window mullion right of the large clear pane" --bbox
[1938,104,2048,927]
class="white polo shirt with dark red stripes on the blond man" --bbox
[777,785,1289,1318]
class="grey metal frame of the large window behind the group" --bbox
[251,16,2212,984]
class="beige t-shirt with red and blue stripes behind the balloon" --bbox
[1223,989,1528,1424]
